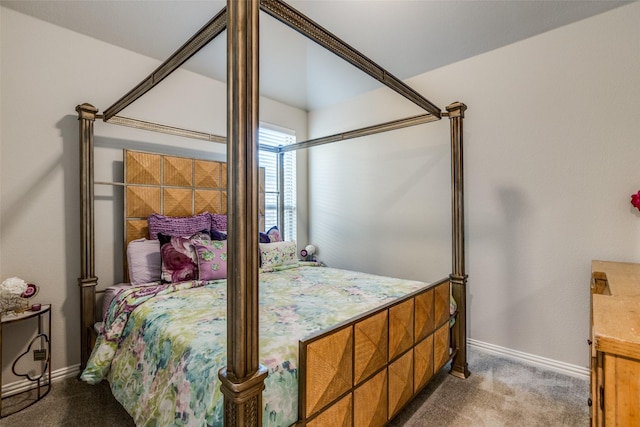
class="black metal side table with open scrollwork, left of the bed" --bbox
[0,304,51,418]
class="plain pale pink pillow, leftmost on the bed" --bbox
[127,238,162,285]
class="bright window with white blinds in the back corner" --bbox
[258,124,296,240]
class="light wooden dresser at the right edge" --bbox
[589,261,640,426]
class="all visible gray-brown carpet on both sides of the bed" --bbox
[0,351,589,427]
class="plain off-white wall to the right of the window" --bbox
[309,2,640,367]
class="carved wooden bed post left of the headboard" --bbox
[76,104,98,371]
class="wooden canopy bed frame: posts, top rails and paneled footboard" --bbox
[76,0,469,426]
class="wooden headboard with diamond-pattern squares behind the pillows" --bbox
[124,150,265,252]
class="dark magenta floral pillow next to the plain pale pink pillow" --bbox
[158,233,209,283]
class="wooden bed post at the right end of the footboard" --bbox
[447,102,470,378]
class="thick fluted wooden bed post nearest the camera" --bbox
[218,0,267,426]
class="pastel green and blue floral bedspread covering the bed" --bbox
[81,266,425,426]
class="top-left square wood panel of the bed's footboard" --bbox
[305,327,353,416]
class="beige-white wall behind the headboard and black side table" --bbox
[0,7,307,385]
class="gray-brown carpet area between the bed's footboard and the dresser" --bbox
[389,351,589,427]
